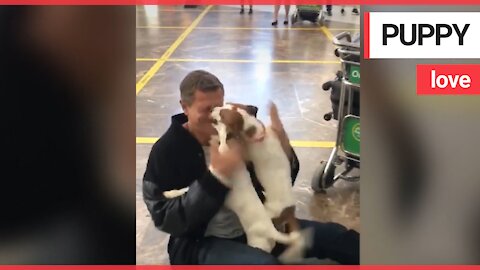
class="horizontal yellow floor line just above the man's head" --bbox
[137,58,340,65]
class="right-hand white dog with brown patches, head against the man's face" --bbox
[212,104,311,262]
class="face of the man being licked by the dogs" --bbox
[181,88,224,136]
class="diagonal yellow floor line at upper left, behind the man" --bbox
[136,5,212,95]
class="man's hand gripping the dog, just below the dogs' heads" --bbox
[210,139,245,180]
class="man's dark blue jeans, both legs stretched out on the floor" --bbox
[198,220,360,265]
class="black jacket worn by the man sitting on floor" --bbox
[143,114,299,264]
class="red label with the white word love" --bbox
[417,65,480,95]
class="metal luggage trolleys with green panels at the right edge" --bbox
[311,32,360,192]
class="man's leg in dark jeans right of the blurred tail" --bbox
[299,220,360,264]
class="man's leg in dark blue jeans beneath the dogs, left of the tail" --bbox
[198,237,280,265]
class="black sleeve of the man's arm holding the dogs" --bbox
[143,140,228,236]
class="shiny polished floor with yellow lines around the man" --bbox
[136,6,360,264]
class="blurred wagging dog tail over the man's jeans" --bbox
[278,228,313,264]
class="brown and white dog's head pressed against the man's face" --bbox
[211,104,265,142]
